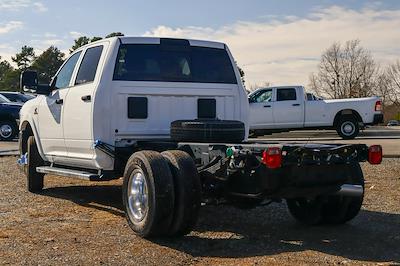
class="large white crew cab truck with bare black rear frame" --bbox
[18,37,382,237]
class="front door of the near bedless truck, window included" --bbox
[35,52,81,161]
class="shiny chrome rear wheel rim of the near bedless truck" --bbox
[128,172,149,222]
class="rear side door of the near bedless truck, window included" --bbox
[63,44,105,167]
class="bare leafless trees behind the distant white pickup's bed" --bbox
[309,40,400,107]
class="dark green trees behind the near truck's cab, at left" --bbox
[0,32,124,91]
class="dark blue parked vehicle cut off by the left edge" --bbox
[0,95,22,140]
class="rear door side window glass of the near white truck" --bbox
[75,46,103,85]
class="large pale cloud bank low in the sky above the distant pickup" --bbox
[144,6,400,85]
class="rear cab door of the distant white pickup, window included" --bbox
[273,87,304,129]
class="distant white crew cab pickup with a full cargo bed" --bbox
[249,86,383,139]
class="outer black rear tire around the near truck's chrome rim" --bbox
[122,151,174,237]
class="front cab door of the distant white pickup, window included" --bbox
[249,89,274,129]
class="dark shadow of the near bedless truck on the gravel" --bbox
[43,185,400,263]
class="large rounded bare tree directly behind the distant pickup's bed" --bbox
[309,40,379,99]
